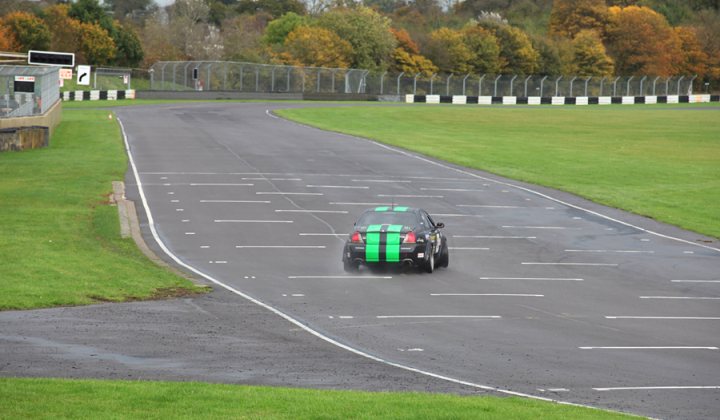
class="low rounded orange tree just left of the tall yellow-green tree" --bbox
[280,26,352,68]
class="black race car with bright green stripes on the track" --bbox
[342,206,450,273]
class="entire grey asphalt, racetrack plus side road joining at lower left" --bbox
[0,104,720,419]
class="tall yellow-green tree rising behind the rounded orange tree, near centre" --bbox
[318,7,396,70]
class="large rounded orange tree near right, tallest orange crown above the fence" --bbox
[607,6,682,76]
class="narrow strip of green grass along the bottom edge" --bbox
[0,378,636,420]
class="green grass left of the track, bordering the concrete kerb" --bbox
[0,106,208,309]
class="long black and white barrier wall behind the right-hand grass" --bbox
[405,95,720,105]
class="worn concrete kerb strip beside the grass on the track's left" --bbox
[110,181,210,286]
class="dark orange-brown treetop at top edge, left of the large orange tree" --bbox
[550,0,608,39]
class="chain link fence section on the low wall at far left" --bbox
[0,66,60,118]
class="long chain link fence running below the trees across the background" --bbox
[148,61,696,97]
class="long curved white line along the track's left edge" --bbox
[121,118,632,409]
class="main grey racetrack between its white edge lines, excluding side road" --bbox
[117,104,720,418]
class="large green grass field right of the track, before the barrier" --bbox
[277,104,720,238]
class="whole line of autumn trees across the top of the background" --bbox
[0,0,720,84]
